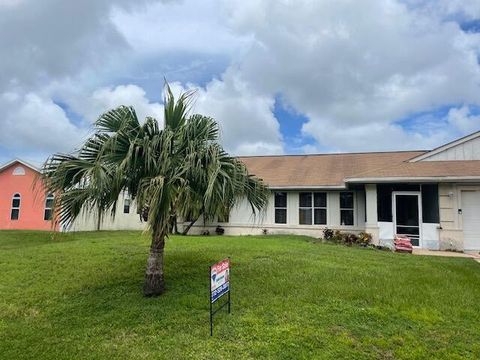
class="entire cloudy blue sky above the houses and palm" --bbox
[0,0,480,163]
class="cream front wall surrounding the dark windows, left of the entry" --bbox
[189,190,365,237]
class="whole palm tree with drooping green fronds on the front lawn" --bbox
[43,84,268,296]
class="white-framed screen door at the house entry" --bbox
[392,191,422,246]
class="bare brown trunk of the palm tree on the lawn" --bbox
[143,231,165,296]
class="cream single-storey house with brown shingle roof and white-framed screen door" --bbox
[186,132,480,250]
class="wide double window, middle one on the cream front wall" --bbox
[298,192,327,225]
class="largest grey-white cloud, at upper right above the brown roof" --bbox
[220,0,480,150]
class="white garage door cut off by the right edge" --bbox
[462,191,480,250]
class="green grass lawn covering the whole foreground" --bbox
[0,231,480,360]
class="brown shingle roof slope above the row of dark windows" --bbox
[240,151,425,188]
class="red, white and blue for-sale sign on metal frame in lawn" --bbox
[209,258,230,336]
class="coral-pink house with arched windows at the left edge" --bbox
[0,159,58,230]
